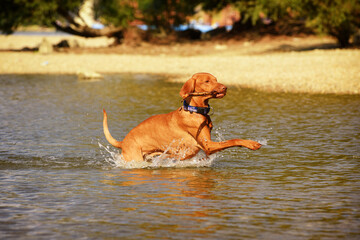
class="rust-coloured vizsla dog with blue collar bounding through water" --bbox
[103,73,261,161]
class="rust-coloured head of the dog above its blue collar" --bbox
[180,73,227,100]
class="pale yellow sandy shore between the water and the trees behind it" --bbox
[0,36,360,94]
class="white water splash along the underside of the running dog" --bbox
[98,143,216,169]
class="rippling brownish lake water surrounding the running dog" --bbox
[0,75,360,239]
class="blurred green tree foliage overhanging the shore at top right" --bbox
[202,0,360,47]
